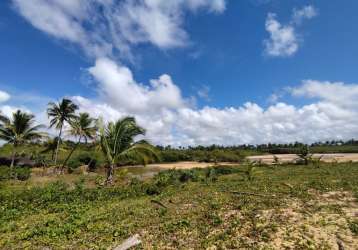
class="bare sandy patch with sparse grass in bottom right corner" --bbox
[261,192,358,250]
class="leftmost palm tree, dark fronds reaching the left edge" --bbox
[0,110,44,172]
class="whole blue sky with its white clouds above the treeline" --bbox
[0,0,358,145]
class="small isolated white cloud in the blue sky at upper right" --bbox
[264,5,317,57]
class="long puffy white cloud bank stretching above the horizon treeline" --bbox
[67,58,358,146]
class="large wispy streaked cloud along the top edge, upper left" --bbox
[13,0,225,57]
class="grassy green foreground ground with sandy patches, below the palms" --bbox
[0,163,358,249]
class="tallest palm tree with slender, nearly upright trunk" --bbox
[47,98,78,165]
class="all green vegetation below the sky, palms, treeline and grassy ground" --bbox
[0,99,358,249]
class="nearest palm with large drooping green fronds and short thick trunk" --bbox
[100,117,159,184]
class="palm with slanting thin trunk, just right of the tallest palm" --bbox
[62,113,97,169]
